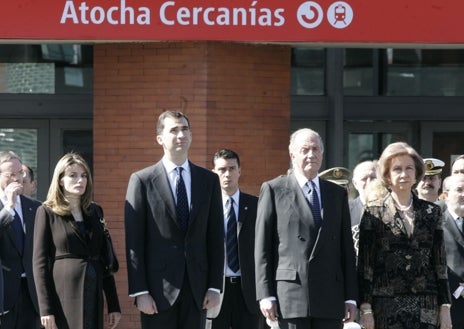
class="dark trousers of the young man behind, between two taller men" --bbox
[212,277,265,329]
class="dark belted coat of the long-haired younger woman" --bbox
[33,205,120,329]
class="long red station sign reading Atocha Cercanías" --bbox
[0,0,464,44]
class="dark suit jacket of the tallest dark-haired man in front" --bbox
[125,161,224,328]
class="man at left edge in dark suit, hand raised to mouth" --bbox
[0,151,40,329]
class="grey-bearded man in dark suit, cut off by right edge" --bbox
[443,174,464,329]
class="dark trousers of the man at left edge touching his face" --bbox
[0,278,41,329]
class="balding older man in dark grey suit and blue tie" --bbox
[255,129,358,329]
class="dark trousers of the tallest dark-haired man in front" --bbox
[140,274,206,329]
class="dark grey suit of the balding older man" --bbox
[255,173,358,326]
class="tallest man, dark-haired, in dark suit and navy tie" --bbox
[125,111,224,329]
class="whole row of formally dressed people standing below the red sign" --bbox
[0,111,464,329]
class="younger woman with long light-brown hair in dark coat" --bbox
[33,153,121,329]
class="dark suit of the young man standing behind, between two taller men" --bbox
[208,192,263,329]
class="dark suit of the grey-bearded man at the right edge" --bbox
[443,210,464,329]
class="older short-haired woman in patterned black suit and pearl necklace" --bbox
[358,142,451,329]
